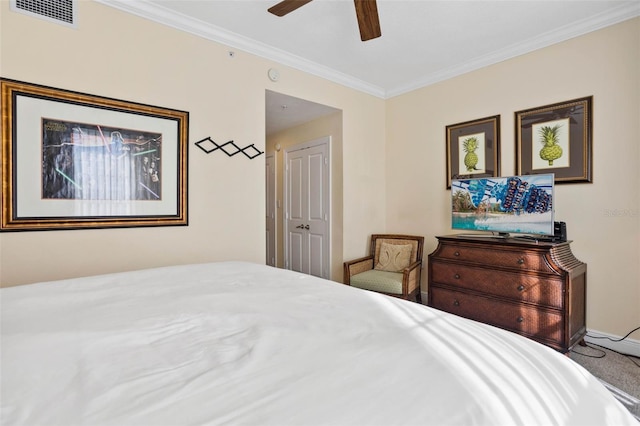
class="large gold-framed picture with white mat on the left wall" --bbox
[0,79,189,231]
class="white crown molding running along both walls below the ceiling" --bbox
[96,0,640,99]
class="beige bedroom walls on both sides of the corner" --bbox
[0,1,640,335]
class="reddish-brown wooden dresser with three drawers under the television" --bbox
[428,235,587,352]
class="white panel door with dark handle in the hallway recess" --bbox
[285,137,330,278]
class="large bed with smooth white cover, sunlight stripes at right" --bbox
[0,262,638,426]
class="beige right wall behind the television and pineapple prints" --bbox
[386,19,640,336]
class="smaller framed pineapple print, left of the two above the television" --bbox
[446,115,500,189]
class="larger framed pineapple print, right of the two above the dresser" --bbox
[515,96,593,183]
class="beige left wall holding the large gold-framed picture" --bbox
[0,1,385,286]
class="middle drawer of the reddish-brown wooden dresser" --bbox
[430,260,564,309]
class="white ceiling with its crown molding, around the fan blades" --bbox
[98,0,640,132]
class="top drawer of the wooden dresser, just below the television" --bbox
[437,244,555,273]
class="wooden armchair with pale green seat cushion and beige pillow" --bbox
[344,234,424,302]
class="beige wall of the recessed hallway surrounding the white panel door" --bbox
[267,112,344,282]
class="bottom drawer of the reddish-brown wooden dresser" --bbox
[429,287,564,342]
